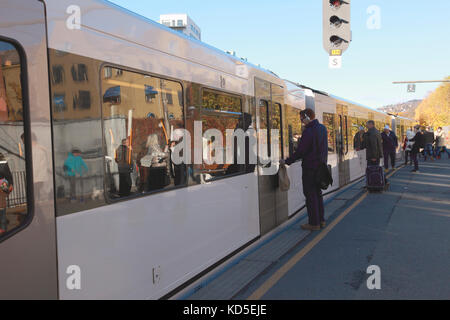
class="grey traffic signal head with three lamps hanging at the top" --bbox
[322,0,352,54]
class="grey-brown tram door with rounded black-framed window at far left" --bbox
[0,0,58,300]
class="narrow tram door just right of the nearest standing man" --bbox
[336,104,353,187]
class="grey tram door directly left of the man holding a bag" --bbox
[255,79,288,235]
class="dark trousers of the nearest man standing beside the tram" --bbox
[302,168,325,226]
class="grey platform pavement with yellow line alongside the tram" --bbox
[176,159,450,300]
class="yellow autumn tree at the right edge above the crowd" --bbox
[416,77,450,128]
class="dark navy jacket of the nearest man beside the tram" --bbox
[286,120,328,169]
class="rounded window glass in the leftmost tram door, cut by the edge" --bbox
[0,40,28,239]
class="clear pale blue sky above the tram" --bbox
[107,0,450,108]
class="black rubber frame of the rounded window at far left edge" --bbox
[0,35,35,244]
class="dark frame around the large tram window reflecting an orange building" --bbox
[99,62,190,204]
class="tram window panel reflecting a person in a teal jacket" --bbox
[49,49,107,216]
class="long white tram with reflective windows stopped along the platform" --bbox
[0,0,412,299]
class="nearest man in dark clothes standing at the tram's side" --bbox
[280,109,328,231]
